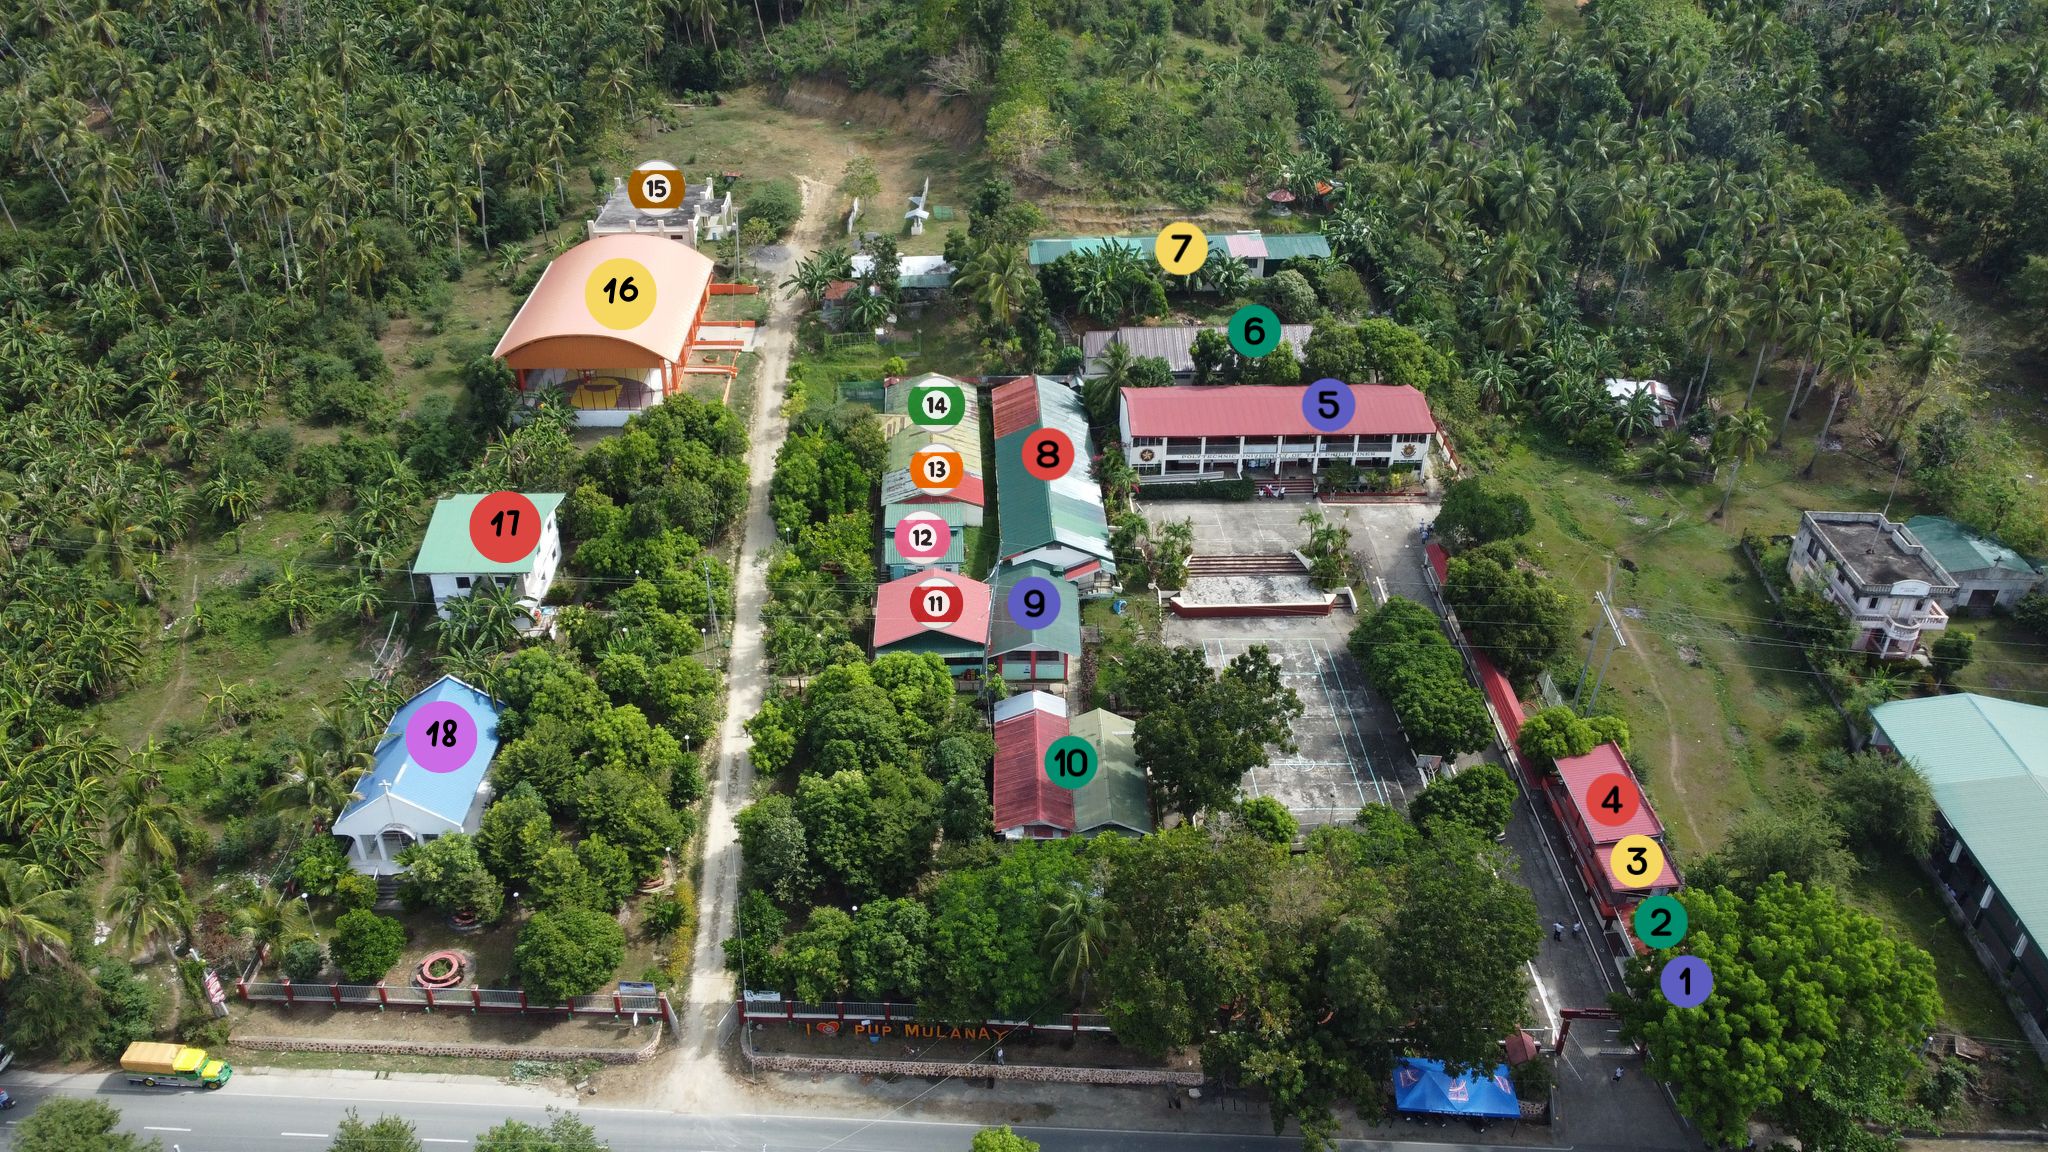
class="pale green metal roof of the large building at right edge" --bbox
[1870,693,2048,937]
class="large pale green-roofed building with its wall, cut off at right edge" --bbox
[1870,693,2048,1043]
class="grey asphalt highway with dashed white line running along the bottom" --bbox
[0,1078,1581,1152]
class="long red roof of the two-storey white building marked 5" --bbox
[1122,383,1436,437]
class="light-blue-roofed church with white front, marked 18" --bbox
[334,676,500,875]
